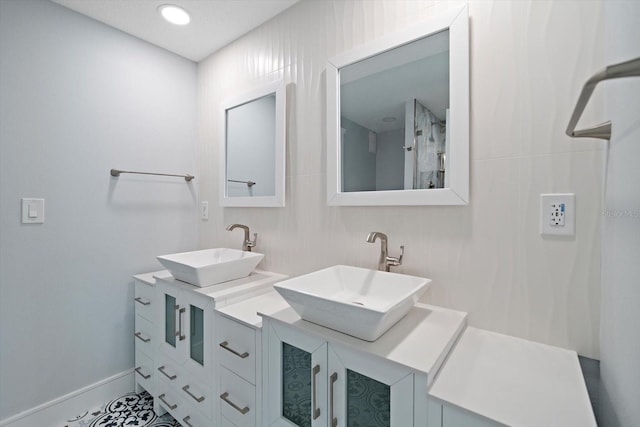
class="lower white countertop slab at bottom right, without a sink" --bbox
[429,327,596,427]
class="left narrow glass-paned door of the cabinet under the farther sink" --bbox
[156,281,187,364]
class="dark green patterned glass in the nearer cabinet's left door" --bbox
[282,342,311,427]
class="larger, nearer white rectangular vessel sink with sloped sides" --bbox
[273,265,431,341]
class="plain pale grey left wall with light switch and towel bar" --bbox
[0,0,200,422]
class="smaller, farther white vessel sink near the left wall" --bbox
[157,248,264,287]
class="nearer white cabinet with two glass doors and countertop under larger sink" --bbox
[263,304,466,427]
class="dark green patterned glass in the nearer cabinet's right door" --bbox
[347,369,391,427]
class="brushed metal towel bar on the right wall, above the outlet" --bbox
[567,58,640,140]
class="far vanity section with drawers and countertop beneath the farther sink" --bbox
[134,271,286,427]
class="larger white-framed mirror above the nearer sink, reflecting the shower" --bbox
[326,5,469,206]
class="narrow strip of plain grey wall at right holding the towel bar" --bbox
[596,1,640,427]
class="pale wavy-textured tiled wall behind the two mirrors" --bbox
[198,0,604,358]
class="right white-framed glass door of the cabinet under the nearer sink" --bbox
[328,344,413,427]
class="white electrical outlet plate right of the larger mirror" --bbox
[540,193,576,236]
